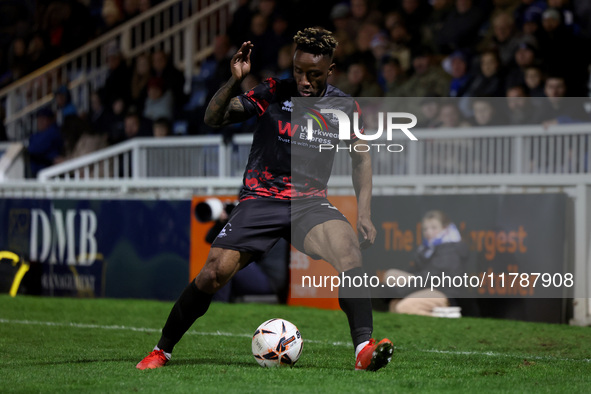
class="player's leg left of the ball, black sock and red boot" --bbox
[136,247,251,369]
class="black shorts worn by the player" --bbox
[211,197,348,258]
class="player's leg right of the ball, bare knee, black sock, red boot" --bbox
[304,220,393,371]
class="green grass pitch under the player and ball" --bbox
[0,296,591,393]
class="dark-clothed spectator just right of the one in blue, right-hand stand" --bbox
[465,51,504,97]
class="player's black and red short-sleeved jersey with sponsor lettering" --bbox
[238,78,359,201]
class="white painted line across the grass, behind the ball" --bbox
[0,318,591,363]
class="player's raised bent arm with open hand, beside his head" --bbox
[204,41,253,127]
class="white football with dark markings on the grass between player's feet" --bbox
[252,319,304,368]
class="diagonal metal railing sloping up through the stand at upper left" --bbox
[0,0,237,141]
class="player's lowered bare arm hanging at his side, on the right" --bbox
[351,141,376,249]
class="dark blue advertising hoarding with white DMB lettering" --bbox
[0,199,191,300]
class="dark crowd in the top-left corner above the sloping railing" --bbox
[0,0,162,88]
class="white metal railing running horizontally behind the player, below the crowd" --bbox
[39,123,591,182]
